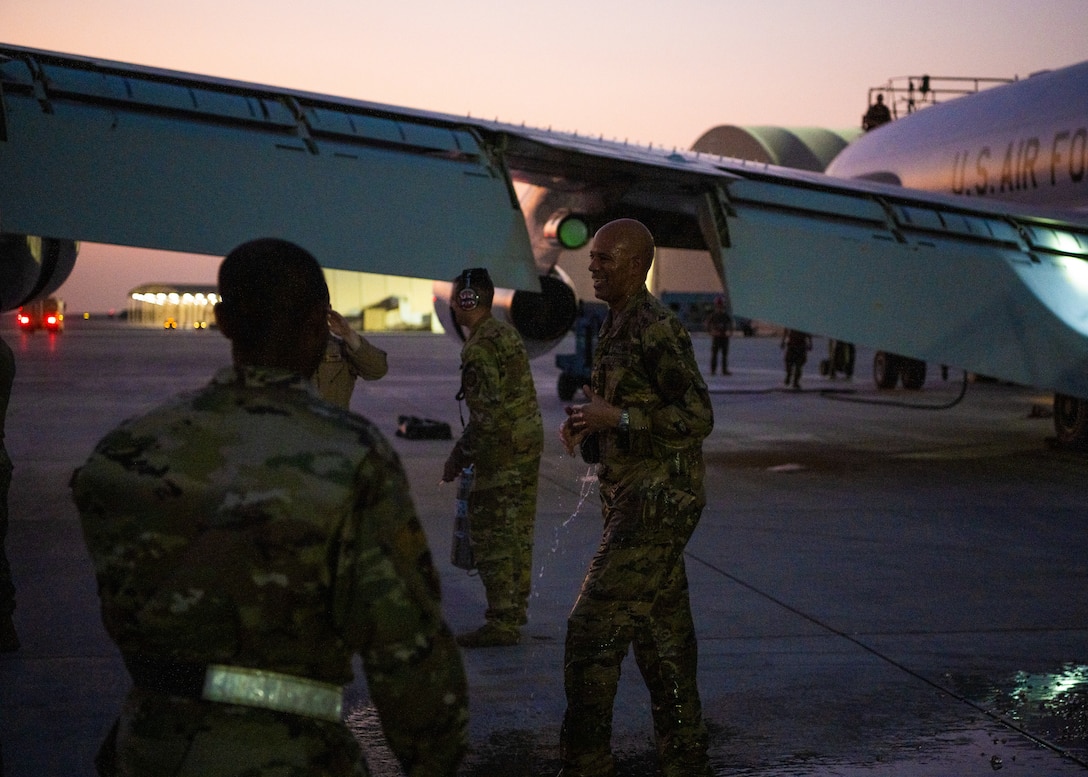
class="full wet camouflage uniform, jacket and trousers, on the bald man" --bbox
[560,288,714,777]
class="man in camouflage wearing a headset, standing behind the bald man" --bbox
[443,269,544,648]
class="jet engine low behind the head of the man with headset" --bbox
[434,267,578,359]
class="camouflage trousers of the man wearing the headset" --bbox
[469,456,540,629]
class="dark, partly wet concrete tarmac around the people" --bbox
[0,317,1088,777]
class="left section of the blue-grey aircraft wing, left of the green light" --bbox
[0,46,539,288]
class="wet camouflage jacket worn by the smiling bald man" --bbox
[592,287,714,507]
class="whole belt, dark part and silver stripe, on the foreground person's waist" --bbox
[125,656,344,723]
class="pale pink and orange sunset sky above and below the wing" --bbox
[0,0,1088,313]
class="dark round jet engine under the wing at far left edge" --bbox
[0,233,79,310]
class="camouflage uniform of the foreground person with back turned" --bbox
[73,367,468,777]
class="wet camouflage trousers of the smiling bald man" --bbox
[559,489,710,777]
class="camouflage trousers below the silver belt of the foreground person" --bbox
[95,688,370,777]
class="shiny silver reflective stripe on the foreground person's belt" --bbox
[201,664,344,723]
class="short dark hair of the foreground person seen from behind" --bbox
[219,237,329,346]
